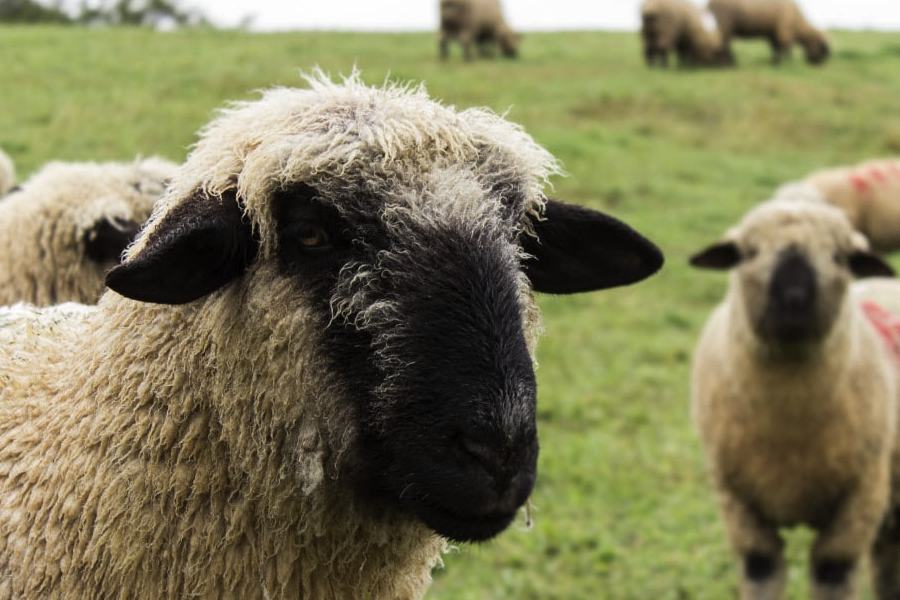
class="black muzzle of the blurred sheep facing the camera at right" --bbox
[761,249,825,343]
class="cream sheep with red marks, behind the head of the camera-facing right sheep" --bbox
[776,158,900,252]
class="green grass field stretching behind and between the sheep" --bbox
[0,27,900,600]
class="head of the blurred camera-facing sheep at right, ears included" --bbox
[691,200,892,353]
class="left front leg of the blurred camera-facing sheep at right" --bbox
[719,490,787,600]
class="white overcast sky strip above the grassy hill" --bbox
[171,0,900,31]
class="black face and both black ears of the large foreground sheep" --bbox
[107,184,662,541]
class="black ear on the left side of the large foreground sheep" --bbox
[106,192,259,304]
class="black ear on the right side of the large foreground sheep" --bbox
[521,200,663,294]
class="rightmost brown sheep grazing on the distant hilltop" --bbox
[708,0,831,65]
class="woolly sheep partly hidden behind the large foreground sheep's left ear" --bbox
[0,157,177,306]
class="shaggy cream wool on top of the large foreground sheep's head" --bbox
[141,73,560,256]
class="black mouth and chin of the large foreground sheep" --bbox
[404,494,519,542]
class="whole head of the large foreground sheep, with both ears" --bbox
[107,74,661,540]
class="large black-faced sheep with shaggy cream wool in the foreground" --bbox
[0,71,663,600]
